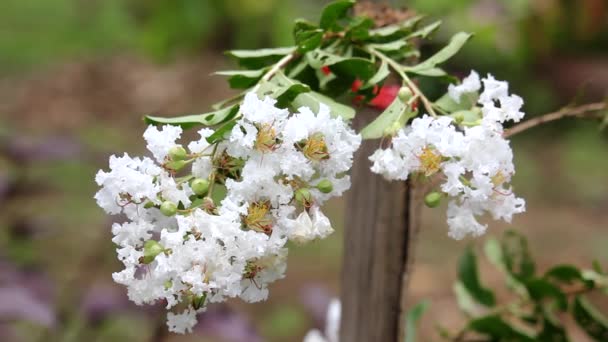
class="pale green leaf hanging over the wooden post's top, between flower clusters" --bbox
[361,92,416,139]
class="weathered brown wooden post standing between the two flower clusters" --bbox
[340,111,415,342]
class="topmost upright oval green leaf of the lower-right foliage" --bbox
[501,230,536,281]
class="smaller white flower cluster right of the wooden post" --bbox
[370,71,525,239]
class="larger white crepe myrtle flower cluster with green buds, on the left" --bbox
[95,93,361,333]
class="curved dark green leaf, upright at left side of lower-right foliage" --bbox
[458,247,496,307]
